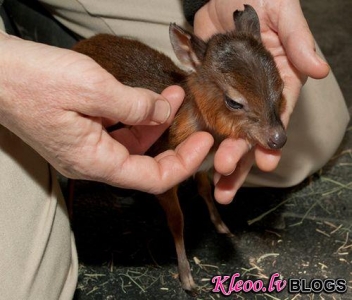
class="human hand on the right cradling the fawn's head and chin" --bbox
[194,0,329,203]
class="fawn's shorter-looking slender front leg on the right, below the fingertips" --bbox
[195,172,232,235]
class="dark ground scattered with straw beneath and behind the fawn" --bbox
[72,0,352,300]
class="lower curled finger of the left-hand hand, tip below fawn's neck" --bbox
[106,132,214,194]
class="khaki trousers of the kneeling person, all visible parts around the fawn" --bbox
[0,0,349,300]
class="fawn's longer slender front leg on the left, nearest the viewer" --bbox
[157,186,197,293]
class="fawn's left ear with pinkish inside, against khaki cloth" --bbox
[169,23,207,71]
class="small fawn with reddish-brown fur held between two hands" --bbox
[74,5,286,291]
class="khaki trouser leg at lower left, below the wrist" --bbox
[0,125,78,300]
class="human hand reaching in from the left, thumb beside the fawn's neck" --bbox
[0,34,213,193]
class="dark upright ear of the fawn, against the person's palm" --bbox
[233,4,261,41]
